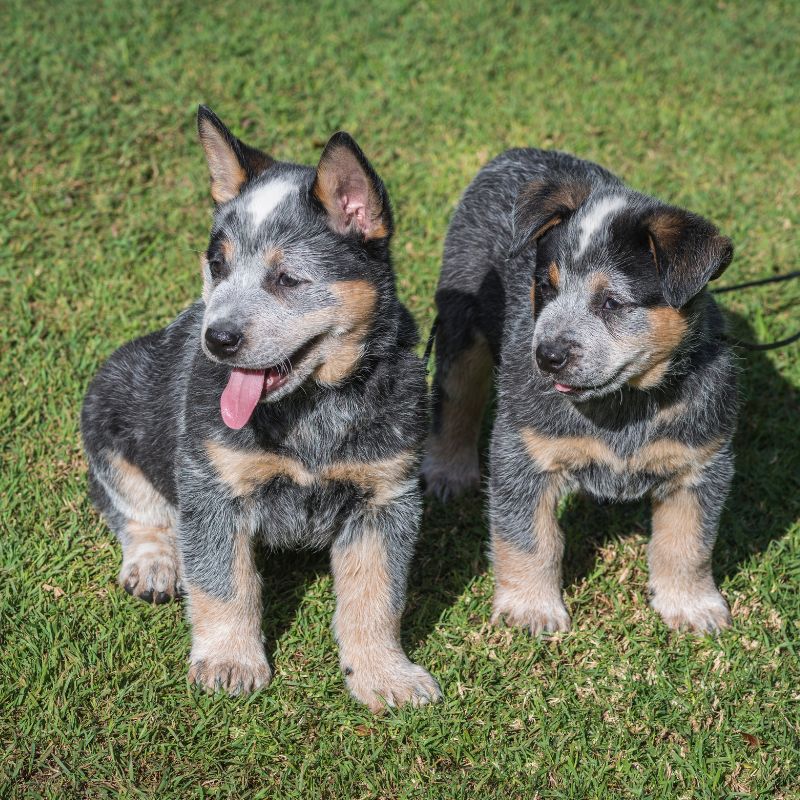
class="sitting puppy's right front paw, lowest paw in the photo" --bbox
[344,658,442,712]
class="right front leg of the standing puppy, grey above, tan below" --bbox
[648,448,733,633]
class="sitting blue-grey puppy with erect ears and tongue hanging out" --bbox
[81,106,441,710]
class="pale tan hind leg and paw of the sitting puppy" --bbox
[89,453,181,603]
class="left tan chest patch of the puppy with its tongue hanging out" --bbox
[205,439,314,497]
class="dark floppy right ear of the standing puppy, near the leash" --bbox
[645,206,733,308]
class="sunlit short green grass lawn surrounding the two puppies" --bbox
[0,0,800,799]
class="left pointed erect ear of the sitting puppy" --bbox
[197,106,275,203]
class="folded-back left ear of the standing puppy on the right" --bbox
[511,177,592,256]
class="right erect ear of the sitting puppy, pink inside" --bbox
[311,131,392,241]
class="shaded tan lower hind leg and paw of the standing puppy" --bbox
[422,336,492,499]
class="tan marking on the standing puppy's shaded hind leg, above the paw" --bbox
[427,336,492,467]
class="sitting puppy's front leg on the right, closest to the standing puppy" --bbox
[331,489,442,711]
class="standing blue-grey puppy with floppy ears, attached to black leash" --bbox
[423,149,737,633]
